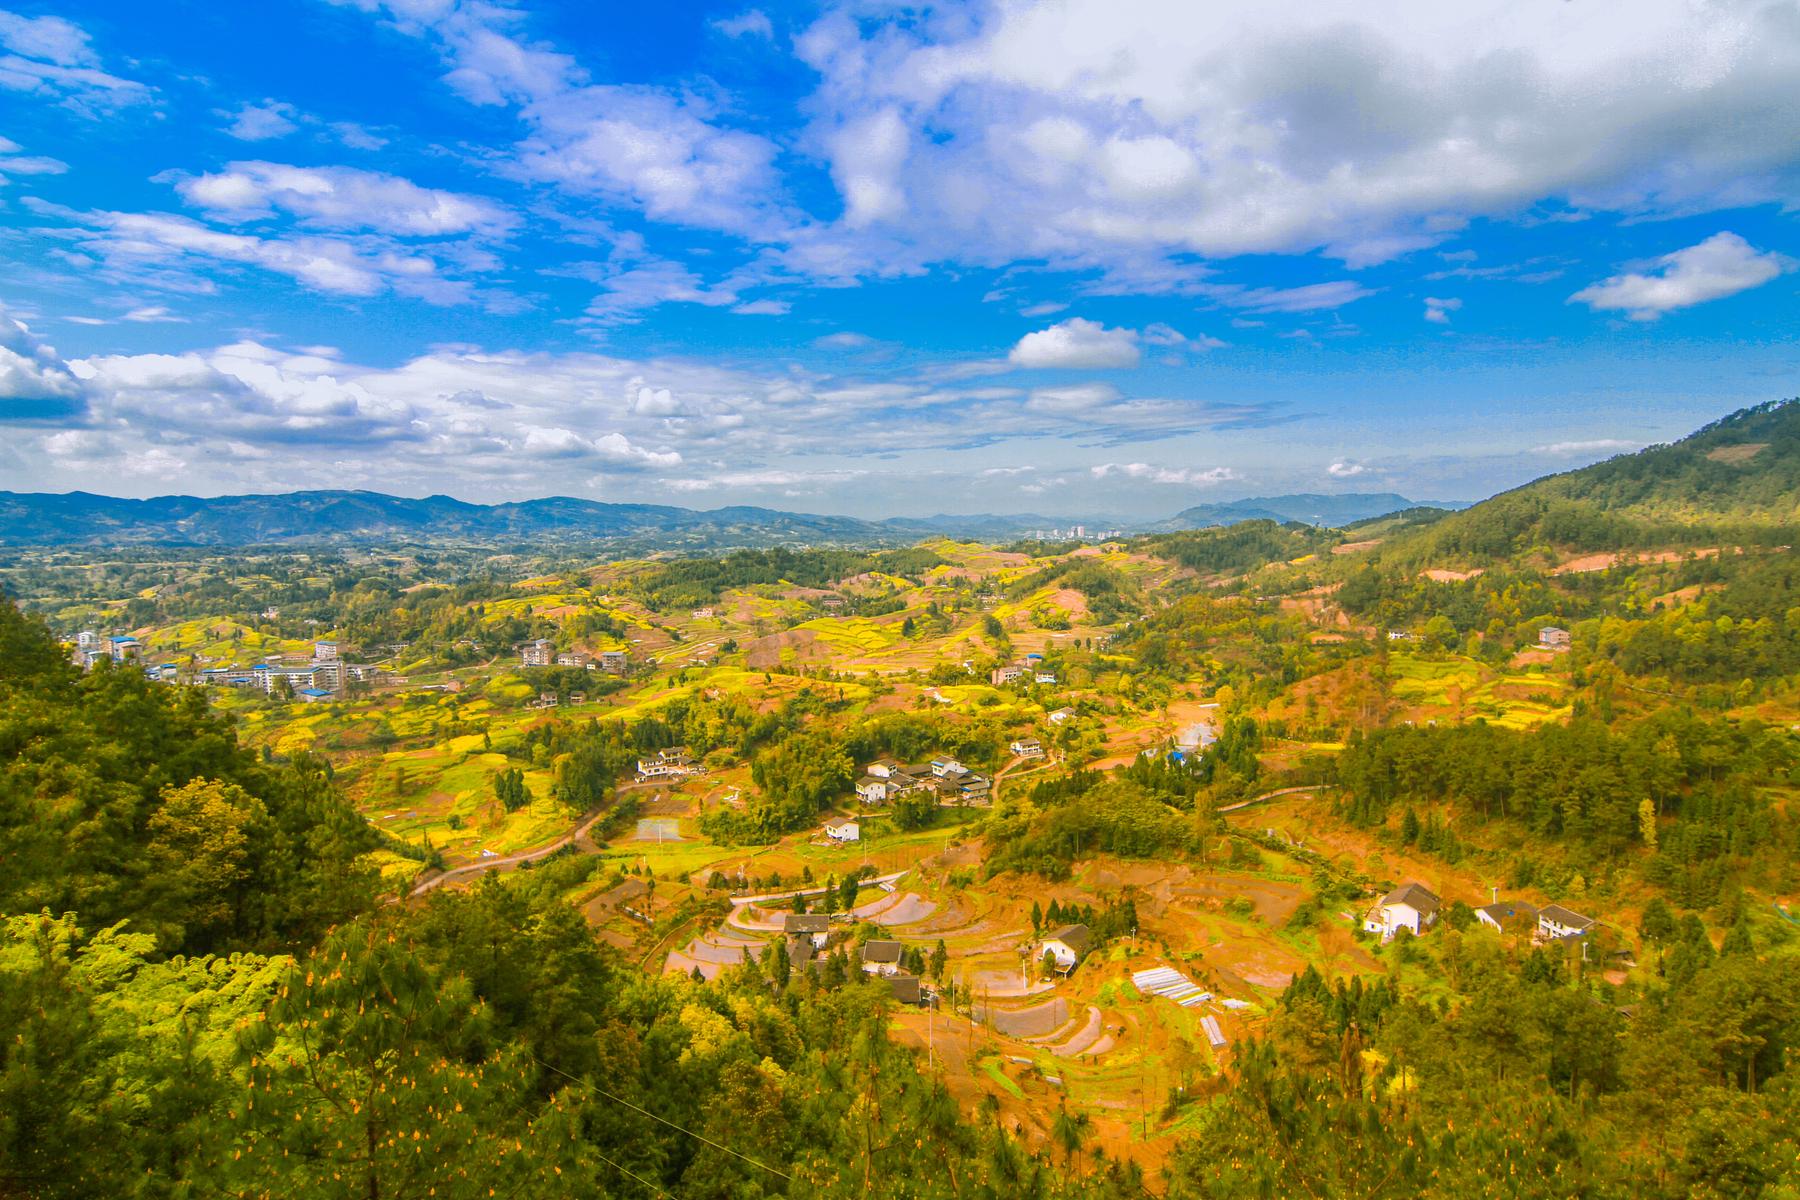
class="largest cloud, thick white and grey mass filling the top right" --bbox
[796,0,1800,282]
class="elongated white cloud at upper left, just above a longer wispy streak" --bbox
[175,162,515,237]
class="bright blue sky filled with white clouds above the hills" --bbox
[0,0,1800,518]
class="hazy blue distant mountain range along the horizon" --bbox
[0,491,1460,549]
